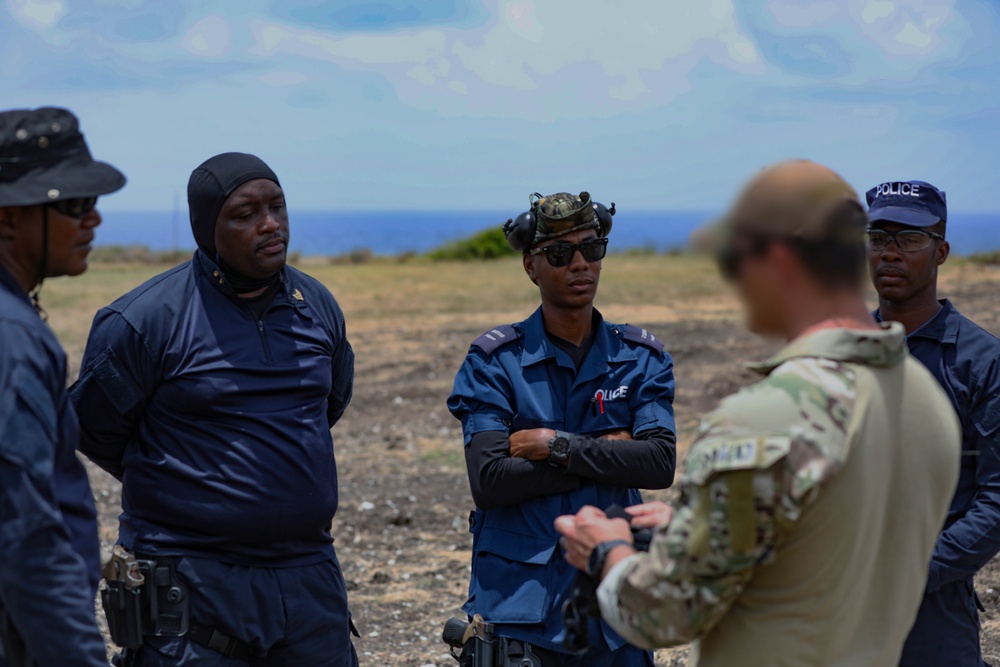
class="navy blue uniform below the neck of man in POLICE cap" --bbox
[884,300,1000,667]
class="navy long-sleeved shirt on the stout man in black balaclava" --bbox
[71,250,354,567]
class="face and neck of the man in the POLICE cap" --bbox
[868,220,951,334]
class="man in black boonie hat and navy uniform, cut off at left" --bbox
[0,108,125,667]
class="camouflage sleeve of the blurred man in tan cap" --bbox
[599,360,853,648]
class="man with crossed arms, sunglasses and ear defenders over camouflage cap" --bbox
[448,192,676,667]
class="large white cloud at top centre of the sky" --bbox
[250,0,764,115]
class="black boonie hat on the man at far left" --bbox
[0,107,125,206]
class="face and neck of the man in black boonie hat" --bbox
[0,204,101,292]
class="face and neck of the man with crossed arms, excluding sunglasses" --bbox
[524,229,601,345]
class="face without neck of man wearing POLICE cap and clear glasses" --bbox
[868,220,950,303]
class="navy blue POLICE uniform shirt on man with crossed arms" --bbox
[448,309,675,651]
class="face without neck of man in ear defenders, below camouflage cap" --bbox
[524,229,601,310]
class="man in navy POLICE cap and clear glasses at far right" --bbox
[868,181,1000,667]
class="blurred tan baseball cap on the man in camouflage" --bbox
[716,160,864,244]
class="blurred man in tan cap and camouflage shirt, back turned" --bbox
[557,161,959,667]
